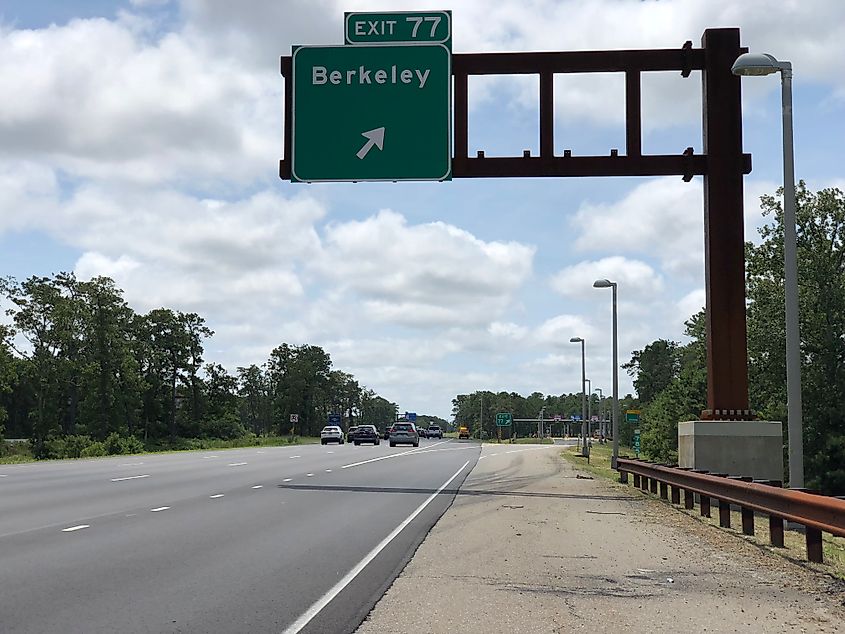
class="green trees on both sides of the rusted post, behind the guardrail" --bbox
[624,181,845,495]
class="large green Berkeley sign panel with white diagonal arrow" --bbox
[291,44,452,182]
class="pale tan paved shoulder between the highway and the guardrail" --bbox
[358,447,845,634]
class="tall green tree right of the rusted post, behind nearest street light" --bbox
[746,181,845,494]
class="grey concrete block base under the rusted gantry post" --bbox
[678,420,783,480]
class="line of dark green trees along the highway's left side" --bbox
[0,273,397,457]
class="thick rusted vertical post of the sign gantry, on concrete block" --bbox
[701,29,748,419]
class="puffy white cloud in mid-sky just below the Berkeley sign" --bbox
[320,210,534,326]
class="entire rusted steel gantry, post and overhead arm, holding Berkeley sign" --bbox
[279,28,753,420]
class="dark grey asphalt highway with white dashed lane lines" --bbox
[0,440,480,634]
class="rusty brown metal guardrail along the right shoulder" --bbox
[617,458,845,563]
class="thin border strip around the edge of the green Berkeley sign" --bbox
[290,43,452,183]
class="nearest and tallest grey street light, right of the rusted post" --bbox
[731,53,804,488]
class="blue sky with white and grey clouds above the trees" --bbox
[0,0,845,417]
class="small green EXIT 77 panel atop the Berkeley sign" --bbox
[344,11,452,49]
